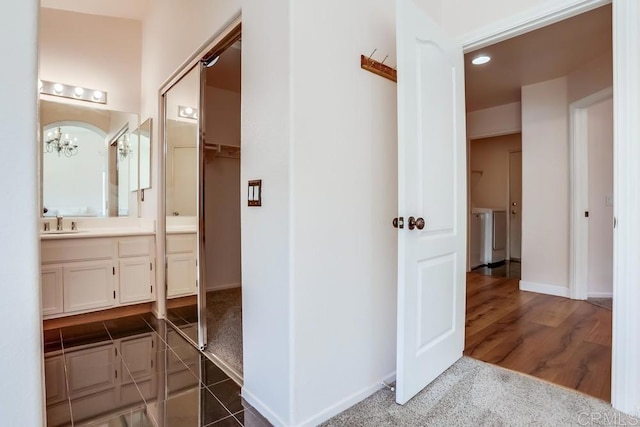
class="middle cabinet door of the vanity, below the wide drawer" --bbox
[63,260,116,312]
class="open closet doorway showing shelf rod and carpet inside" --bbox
[201,40,243,382]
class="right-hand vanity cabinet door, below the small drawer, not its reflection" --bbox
[119,256,153,304]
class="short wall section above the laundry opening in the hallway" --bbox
[467,102,522,139]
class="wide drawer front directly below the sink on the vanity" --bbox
[41,239,113,263]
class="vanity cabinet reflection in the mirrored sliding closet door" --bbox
[167,233,198,298]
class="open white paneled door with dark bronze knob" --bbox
[396,0,466,404]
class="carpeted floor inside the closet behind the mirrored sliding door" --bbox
[207,288,242,375]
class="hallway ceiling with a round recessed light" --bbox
[464,5,612,111]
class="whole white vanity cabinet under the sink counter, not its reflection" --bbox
[41,235,155,319]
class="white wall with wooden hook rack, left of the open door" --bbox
[292,0,410,425]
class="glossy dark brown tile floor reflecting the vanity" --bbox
[44,314,270,427]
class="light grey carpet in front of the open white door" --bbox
[323,357,640,427]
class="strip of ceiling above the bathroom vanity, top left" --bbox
[40,0,151,21]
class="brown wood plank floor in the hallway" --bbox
[464,273,611,402]
